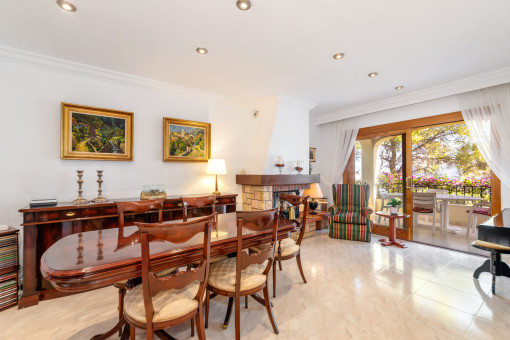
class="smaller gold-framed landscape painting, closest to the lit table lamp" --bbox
[163,118,211,162]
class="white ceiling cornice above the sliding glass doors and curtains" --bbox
[312,67,510,124]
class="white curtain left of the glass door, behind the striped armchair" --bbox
[318,117,359,204]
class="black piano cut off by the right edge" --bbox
[473,209,510,294]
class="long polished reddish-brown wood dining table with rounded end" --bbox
[41,213,296,292]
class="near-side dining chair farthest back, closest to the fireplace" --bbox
[273,193,309,297]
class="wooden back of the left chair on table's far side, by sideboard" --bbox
[116,198,164,249]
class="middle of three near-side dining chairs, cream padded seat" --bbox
[205,209,279,340]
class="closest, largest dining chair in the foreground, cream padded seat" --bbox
[124,213,216,340]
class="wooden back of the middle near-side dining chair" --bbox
[236,208,278,292]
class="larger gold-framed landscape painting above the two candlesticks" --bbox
[60,103,133,161]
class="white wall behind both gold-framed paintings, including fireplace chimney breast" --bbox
[0,61,309,232]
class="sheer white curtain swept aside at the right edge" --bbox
[459,83,510,187]
